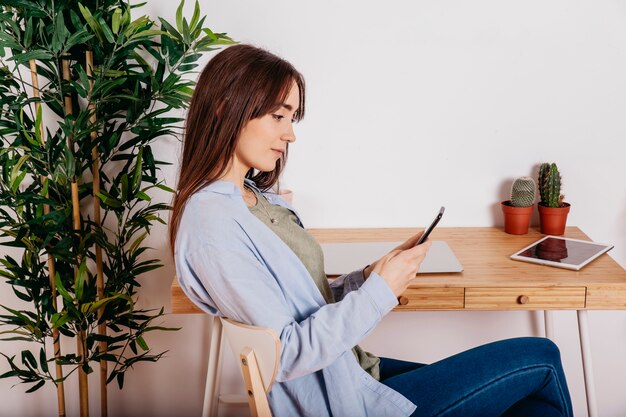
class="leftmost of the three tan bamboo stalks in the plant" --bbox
[30,59,65,417]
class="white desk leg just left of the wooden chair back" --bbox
[202,315,222,417]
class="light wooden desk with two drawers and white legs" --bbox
[172,227,626,417]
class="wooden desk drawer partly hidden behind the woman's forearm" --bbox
[395,288,465,310]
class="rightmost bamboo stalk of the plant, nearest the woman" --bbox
[85,51,108,417]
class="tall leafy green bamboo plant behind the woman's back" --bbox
[0,0,232,416]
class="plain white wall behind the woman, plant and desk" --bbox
[0,0,626,417]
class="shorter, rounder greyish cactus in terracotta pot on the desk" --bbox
[500,177,535,235]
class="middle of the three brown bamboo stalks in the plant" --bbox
[62,57,89,417]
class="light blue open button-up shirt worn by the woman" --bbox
[174,179,415,417]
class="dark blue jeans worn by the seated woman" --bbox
[380,337,573,417]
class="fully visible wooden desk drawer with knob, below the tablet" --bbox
[465,287,585,310]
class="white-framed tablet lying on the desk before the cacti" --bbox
[511,236,613,271]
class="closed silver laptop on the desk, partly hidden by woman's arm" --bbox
[321,240,463,275]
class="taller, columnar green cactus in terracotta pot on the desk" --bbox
[538,162,570,235]
